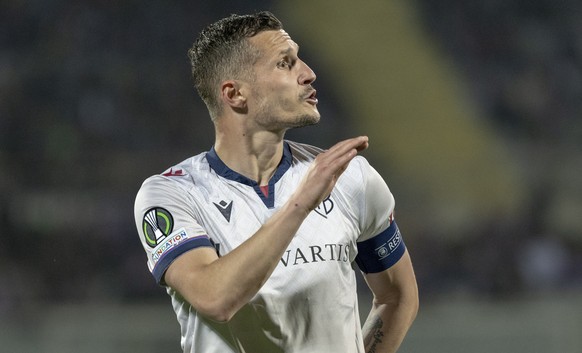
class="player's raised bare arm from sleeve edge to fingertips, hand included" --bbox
[165,137,368,321]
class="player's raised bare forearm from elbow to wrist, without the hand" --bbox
[171,200,308,321]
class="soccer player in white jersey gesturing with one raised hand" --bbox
[135,12,418,353]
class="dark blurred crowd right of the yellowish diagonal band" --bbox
[418,0,582,297]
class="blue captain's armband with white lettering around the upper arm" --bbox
[356,221,406,273]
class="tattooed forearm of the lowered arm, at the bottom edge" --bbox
[362,300,418,353]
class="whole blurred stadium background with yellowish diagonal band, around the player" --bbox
[0,0,582,353]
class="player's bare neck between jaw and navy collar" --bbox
[214,124,284,185]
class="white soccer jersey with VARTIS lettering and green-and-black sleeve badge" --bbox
[135,141,404,353]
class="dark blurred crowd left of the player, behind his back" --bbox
[0,0,276,313]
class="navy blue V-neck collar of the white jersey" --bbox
[206,141,293,208]
